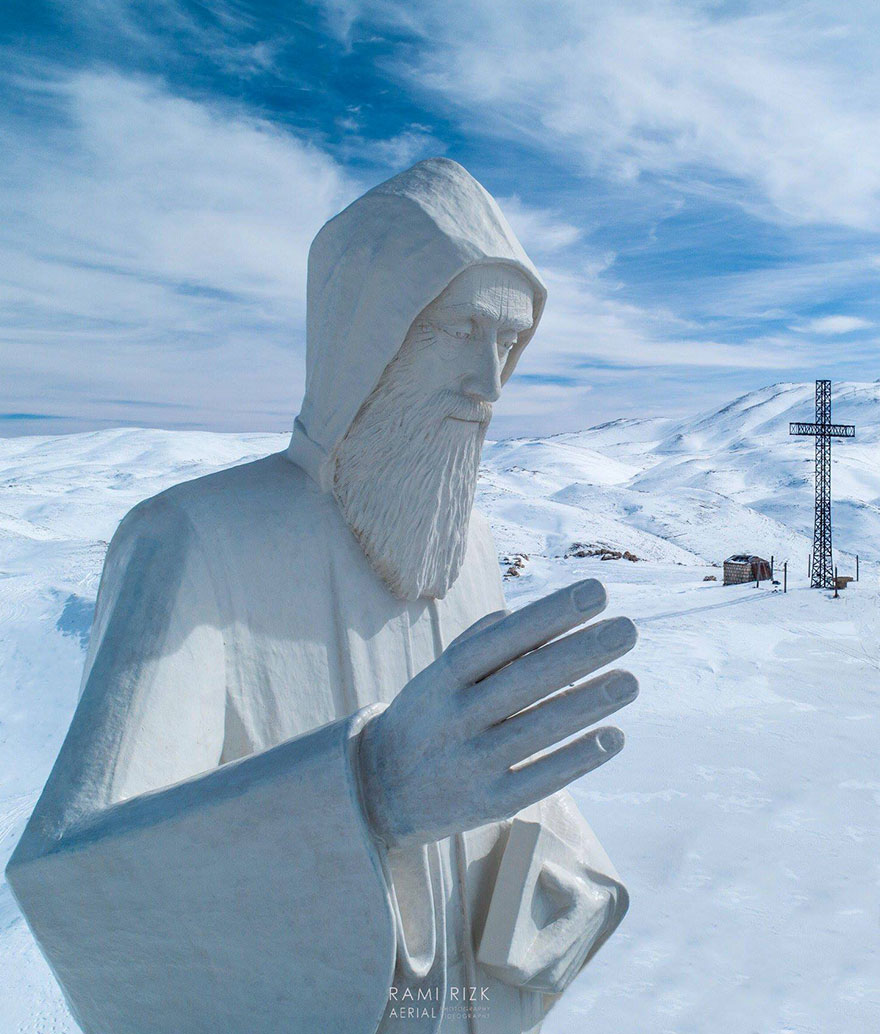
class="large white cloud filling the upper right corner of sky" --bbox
[322,0,880,230]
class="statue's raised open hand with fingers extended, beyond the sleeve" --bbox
[360,579,638,845]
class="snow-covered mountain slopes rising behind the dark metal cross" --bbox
[480,382,880,570]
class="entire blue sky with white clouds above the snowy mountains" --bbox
[0,0,880,435]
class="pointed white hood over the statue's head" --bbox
[287,158,547,489]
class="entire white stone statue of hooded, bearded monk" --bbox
[8,158,637,1034]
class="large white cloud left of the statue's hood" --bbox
[0,73,360,428]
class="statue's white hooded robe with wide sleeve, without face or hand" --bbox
[7,161,627,1034]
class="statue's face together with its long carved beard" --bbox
[333,266,534,600]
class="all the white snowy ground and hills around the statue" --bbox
[0,385,880,1034]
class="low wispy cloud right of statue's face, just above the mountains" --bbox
[491,267,810,437]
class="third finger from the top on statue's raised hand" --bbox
[479,670,639,765]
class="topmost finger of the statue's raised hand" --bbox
[444,578,607,686]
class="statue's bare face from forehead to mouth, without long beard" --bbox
[406,265,535,425]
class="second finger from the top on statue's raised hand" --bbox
[460,617,638,730]
